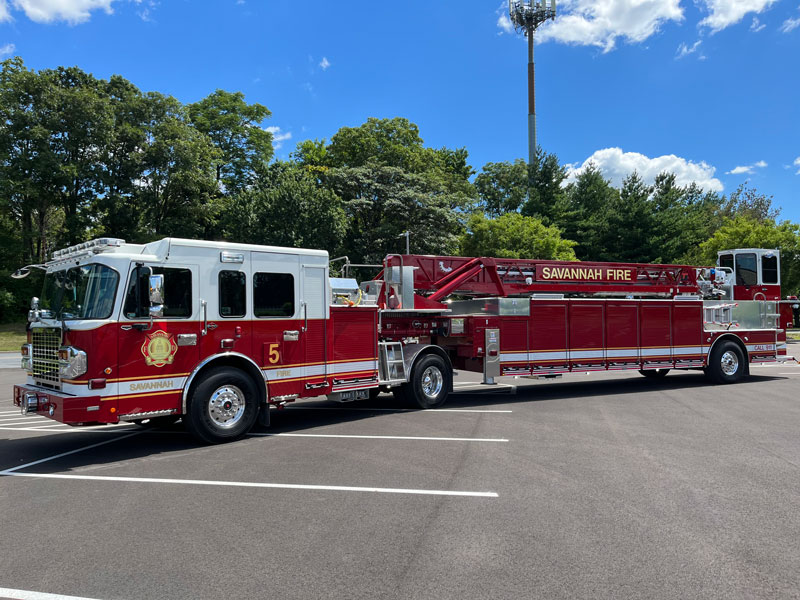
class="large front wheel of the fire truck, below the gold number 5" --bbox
[184,367,258,444]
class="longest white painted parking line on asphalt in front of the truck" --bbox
[0,471,498,498]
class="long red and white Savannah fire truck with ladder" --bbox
[9,238,788,443]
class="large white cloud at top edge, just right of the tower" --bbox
[537,0,683,52]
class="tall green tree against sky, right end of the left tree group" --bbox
[187,90,273,193]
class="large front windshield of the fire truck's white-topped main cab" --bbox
[39,264,119,319]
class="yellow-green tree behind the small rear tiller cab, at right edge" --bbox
[700,215,800,295]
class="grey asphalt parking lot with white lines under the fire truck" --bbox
[0,360,800,599]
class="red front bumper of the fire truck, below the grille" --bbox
[14,385,119,425]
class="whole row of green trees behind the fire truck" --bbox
[0,57,800,320]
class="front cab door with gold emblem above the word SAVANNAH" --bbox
[117,263,203,416]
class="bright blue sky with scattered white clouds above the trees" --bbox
[0,0,800,222]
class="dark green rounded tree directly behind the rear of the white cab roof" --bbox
[223,161,347,252]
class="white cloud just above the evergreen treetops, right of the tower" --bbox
[567,148,722,192]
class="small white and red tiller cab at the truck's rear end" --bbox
[717,248,781,301]
